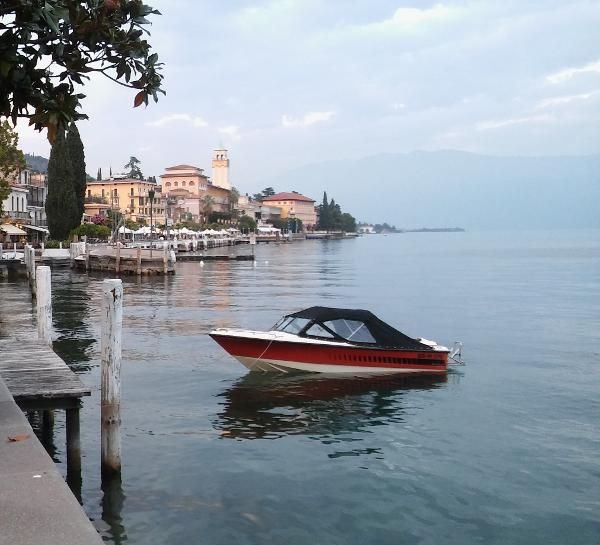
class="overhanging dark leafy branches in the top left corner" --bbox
[0,0,164,143]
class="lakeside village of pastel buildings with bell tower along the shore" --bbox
[0,144,360,246]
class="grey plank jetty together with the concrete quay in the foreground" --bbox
[0,335,102,545]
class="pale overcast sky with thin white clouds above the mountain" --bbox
[15,0,600,192]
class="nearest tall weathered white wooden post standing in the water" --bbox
[100,279,123,475]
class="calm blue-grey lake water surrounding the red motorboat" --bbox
[0,231,600,545]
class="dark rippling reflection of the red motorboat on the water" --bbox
[215,373,448,439]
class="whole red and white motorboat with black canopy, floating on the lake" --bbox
[209,307,450,375]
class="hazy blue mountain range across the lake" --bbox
[261,151,600,229]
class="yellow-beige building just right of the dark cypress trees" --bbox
[85,178,165,223]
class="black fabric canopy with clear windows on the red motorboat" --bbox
[275,307,433,351]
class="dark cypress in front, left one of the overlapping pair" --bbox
[46,130,81,240]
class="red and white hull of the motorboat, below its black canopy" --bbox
[210,333,448,374]
